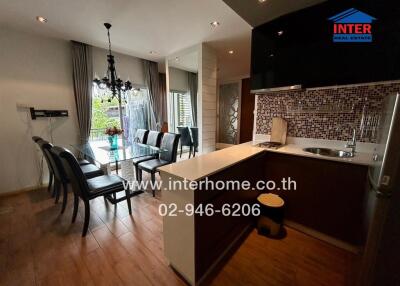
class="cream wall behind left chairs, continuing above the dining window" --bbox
[0,27,144,194]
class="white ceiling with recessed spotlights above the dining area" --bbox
[0,0,251,78]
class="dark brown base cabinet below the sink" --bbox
[265,152,368,246]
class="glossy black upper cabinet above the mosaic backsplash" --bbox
[251,0,400,91]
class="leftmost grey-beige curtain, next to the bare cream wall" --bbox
[71,41,93,143]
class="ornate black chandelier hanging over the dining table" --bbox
[93,23,133,104]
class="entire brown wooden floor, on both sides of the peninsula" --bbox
[0,178,357,286]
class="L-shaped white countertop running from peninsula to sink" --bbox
[159,141,373,181]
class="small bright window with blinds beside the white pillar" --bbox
[171,91,193,127]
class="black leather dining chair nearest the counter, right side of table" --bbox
[138,133,181,197]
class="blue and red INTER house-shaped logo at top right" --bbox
[328,8,376,43]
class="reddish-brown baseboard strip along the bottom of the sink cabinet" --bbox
[284,220,363,254]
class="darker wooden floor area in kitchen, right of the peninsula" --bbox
[212,228,360,286]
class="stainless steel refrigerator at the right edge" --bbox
[360,93,400,286]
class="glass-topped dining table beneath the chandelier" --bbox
[71,139,167,204]
